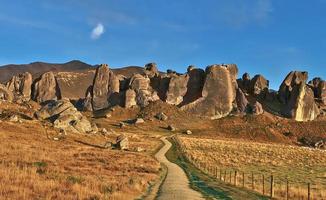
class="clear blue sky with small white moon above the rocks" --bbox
[0,0,326,89]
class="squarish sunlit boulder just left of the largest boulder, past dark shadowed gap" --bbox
[166,74,189,105]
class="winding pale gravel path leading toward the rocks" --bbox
[155,137,204,200]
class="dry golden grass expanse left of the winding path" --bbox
[0,106,160,199]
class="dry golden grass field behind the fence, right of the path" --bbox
[177,136,326,199]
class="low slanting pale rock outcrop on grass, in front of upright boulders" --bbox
[35,100,93,133]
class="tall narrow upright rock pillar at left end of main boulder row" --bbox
[92,64,113,110]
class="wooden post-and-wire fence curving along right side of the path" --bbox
[174,137,326,200]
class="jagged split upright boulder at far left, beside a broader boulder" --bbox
[7,72,33,101]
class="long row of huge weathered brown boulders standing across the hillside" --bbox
[0,63,326,121]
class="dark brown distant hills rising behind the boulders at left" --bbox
[0,60,143,99]
